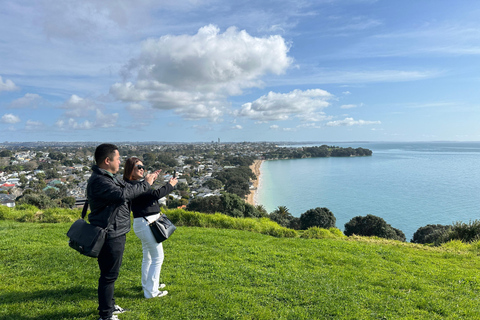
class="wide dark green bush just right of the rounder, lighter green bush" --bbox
[345,214,406,241]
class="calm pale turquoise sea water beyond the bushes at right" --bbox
[255,142,480,241]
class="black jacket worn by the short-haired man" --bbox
[87,165,150,238]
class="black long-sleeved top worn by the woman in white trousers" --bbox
[125,180,173,218]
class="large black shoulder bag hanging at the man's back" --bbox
[67,200,117,258]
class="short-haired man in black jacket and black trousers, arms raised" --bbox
[87,144,159,320]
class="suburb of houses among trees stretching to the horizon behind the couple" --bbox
[0,142,274,207]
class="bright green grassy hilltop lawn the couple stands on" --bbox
[0,220,480,320]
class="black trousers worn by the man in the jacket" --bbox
[98,235,127,318]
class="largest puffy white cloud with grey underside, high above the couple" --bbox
[110,25,292,121]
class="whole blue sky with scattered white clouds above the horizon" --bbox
[0,0,480,142]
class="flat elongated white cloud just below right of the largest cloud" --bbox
[235,89,333,121]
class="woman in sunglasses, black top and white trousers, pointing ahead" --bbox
[123,157,178,299]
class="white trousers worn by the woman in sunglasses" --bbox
[133,214,164,299]
